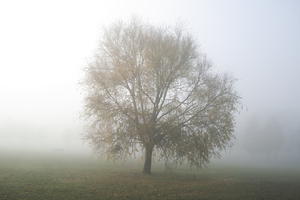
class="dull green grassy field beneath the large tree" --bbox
[0,152,300,200]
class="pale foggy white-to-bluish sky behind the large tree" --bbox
[0,0,300,162]
